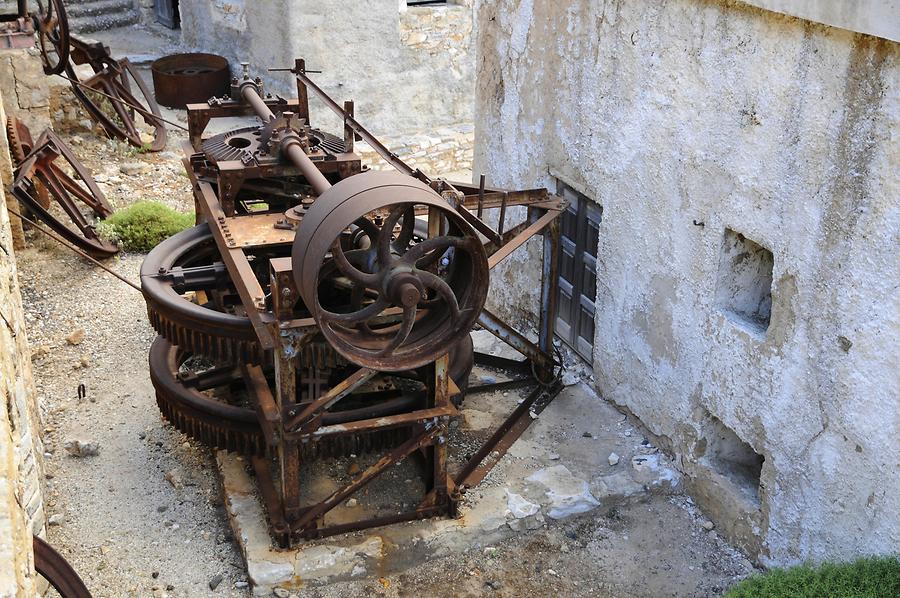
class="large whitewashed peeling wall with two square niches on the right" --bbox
[475,0,900,563]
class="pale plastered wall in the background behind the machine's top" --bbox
[181,0,475,176]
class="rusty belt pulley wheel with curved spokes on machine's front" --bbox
[292,172,489,371]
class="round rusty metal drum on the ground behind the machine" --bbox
[150,52,231,108]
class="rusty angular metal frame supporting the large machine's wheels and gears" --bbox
[150,60,565,547]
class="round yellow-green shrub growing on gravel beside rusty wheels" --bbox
[98,201,194,252]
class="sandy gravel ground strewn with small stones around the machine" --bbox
[17,116,752,598]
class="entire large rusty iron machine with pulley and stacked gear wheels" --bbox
[141,60,564,547]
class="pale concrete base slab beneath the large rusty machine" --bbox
[216,368,679,595]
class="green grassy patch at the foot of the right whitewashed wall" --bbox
[725,556,900,598]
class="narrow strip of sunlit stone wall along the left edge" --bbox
[0,62,45,597]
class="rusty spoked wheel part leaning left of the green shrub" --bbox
[8,126,119,257]
